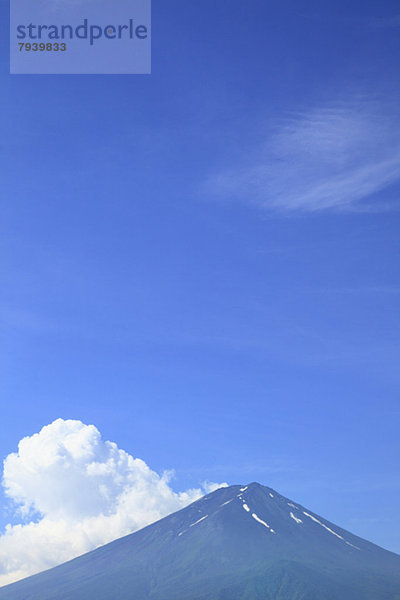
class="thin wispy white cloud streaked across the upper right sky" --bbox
[206,99,400,212]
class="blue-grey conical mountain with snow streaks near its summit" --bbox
[0,483,400,600]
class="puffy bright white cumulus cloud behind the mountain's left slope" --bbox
[0,419,226,586]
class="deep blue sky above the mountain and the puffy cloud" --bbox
[0,0,400,576]
